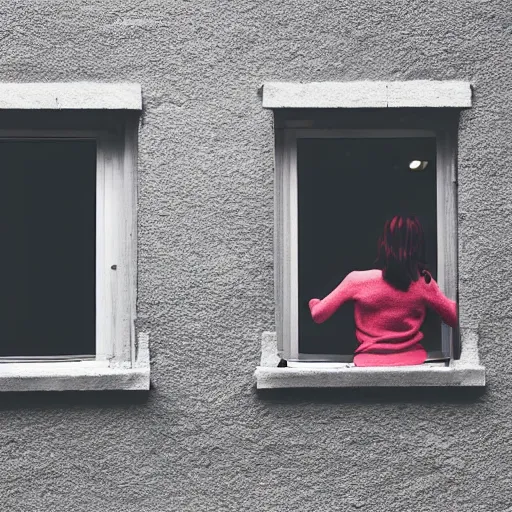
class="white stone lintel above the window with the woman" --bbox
[263,80,472,109]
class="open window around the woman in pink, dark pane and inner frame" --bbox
[286,123,460,362]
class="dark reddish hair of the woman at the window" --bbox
[375,215,430,291]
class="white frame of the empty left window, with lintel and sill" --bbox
[0,84,150,391]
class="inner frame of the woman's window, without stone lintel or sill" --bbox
[274,124,460,364]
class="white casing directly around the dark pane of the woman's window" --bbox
[275,129,457,360]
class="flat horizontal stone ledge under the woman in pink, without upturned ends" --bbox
[255,365,485,389]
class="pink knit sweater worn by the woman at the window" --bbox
[309,270,457,366]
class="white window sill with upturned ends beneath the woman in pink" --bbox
[255,333,485,389]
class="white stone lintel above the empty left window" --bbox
[0,82,142,110]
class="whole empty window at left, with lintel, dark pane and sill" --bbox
[0,84,149,391]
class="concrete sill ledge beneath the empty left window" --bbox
[0,361,149,392]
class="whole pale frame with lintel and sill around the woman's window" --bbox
[255,80,485,389]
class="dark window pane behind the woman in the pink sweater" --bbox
[297,138,441,354]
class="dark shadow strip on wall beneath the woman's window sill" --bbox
[253,386,487,405]
